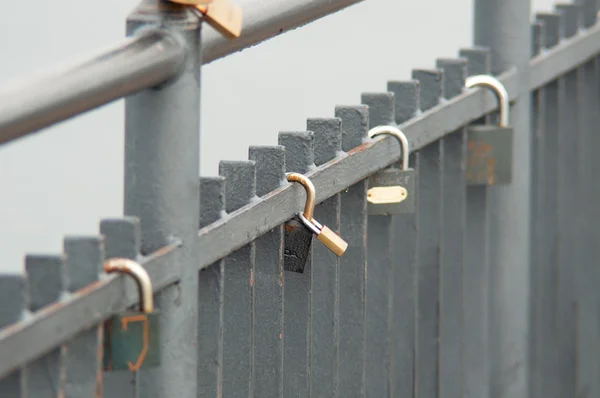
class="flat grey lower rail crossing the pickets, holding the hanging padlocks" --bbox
[0,14,600,377]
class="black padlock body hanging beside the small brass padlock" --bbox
[283,217,313,273]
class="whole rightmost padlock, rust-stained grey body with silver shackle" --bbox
[465,75,514,185]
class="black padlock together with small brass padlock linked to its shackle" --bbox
[284,173,348,273]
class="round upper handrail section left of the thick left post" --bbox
[0,30,185,144]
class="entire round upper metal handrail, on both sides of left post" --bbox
[0,0,362,144]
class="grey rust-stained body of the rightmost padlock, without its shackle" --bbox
[465,125,514,185]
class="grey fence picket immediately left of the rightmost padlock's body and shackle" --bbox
[436,59,468,398]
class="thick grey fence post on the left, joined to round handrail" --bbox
[124,0,201,398]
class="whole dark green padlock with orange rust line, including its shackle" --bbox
[103,258,161,372]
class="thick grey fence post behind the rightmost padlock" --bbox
[474,0,531,398]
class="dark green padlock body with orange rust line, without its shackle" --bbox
[103,311,160,371]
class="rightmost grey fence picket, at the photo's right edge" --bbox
[573,0,600,397]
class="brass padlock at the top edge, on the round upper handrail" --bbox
[170,0,243,39]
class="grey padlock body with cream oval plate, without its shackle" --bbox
[367,168,416,215]
